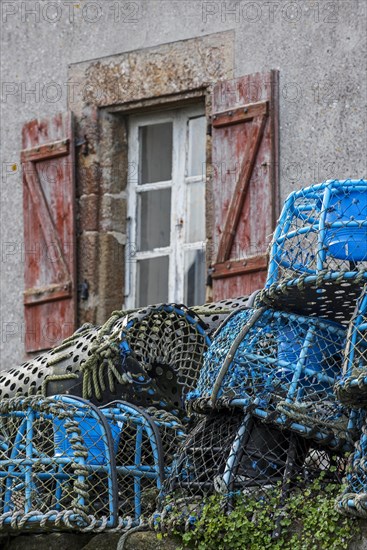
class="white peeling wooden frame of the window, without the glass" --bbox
[124,104,206,308]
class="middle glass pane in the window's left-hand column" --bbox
[138,189,171,250]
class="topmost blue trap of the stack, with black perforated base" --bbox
[260,180,367,323]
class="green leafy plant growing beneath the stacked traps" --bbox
[161,477,359,550]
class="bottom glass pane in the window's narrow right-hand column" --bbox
[184,250,206,306]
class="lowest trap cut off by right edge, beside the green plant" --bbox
[336,424,367,518]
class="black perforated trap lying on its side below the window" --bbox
[0,304,212,414]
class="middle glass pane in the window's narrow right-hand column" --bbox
[186,181,205,243]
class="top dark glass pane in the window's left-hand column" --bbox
[139,122,172,184]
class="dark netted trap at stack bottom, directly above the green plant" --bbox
[156,409,346,531]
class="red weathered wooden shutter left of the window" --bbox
[21,113,76,352]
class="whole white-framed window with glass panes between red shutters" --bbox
[125,105,206,307]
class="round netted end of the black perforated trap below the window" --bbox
[115,304,210,415]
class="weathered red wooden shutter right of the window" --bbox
[212,71,278,300]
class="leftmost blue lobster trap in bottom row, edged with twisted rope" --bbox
[0,397,118,530]
